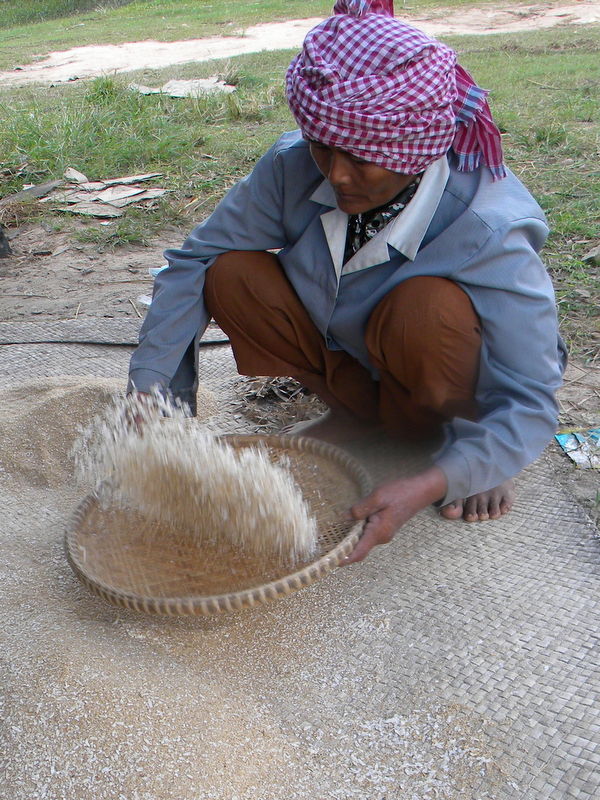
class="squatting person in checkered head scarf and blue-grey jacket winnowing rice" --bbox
[130,0,565,562]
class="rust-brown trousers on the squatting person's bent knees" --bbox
[204,251,481,438]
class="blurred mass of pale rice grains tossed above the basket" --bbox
[74,395,317,562]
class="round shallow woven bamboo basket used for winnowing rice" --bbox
[65,436,370,616]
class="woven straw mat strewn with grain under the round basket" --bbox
[0,320,600,800]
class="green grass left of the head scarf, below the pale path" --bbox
[0,53,293,238]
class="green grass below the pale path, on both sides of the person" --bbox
[0,21,600,358]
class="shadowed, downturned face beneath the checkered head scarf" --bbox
[310,141,415,214]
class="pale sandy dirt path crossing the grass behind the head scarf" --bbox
[0,0,600,87]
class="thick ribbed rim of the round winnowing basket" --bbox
[64,434,372,616]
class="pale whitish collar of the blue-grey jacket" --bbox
[310,156,450,279]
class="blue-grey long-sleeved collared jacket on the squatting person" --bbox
[130,131,565,502]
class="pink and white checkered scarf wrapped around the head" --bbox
[286,0,506,180]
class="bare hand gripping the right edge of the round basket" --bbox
[344,467,447,565]
